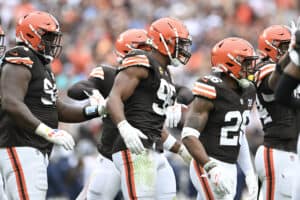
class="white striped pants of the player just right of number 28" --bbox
[255,145,298,200]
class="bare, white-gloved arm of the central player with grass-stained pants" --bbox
[106,67,148,153]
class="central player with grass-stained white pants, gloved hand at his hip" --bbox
[107,18,191,199]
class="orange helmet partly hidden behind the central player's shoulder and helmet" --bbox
[115,29,150,62]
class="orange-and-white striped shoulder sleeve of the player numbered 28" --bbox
[192,80,217,99]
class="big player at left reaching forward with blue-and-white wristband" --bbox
[0,11,104,199]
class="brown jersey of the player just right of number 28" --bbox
[256,62,299,152]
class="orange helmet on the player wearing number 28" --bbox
[211,37,258,80]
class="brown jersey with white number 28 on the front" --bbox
[193,72,255,163]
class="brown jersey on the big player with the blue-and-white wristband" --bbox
[0,46,58,153]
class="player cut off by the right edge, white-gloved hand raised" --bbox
[275,18,300,200]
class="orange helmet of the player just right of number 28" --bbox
[258,25,291,62]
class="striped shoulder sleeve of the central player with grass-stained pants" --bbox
[119,50,151,70]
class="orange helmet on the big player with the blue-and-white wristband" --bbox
[16,11,62,60]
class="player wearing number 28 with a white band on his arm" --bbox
[182,37,258,199]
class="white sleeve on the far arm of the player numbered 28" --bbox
[237,133,254,175]
